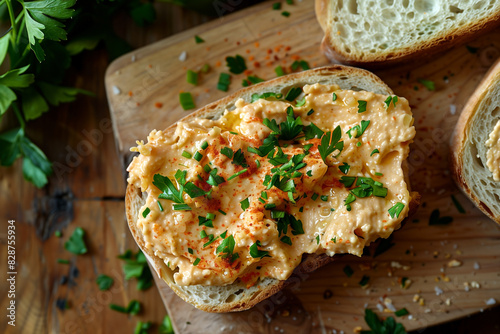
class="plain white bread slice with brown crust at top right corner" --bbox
[316,0,500,67]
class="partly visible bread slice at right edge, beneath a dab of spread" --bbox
[451,60,500,224]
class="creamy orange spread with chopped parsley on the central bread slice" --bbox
[128,84,415,286]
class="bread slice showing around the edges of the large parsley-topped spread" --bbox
[125,66,419,312]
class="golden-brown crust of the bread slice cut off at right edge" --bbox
[450,59,500,224]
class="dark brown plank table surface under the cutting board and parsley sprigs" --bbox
[0,4,500,334]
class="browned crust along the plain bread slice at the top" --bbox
[315,0,500,69]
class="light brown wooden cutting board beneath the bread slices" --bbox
[102,1,500,333]
